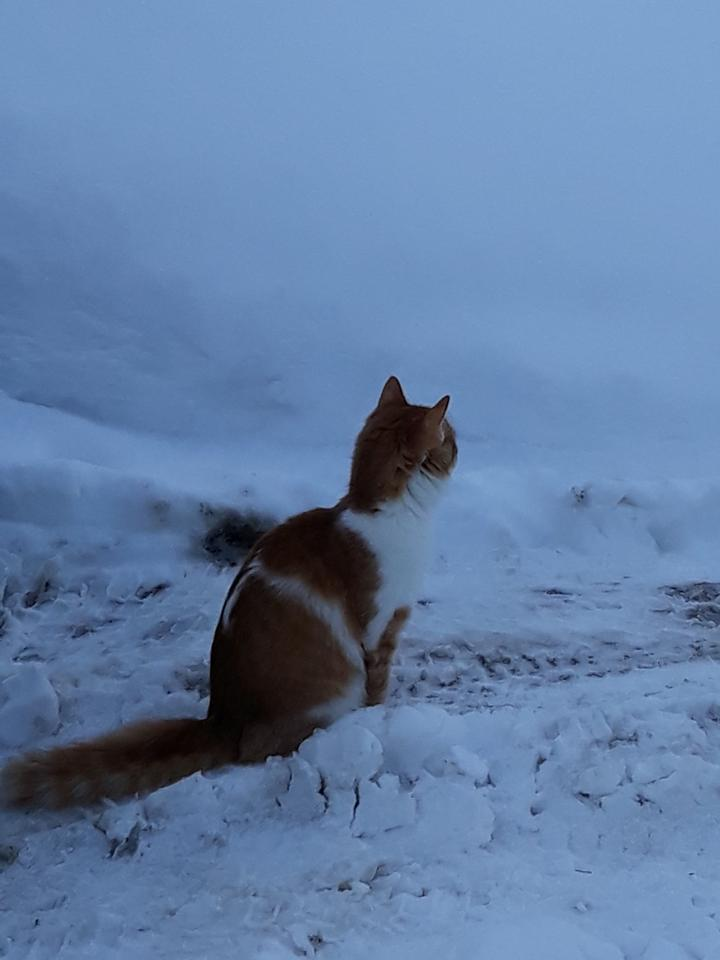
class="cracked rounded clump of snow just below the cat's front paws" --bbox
[277,706,494,856]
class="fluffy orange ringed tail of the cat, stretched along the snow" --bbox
[0,719,238,809]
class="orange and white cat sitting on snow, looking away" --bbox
[2,377,457,808]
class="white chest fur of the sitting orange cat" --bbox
[343,474,443,650]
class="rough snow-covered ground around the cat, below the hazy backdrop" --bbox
[0,385,720,960]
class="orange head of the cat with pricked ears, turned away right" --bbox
[349,377,457,510]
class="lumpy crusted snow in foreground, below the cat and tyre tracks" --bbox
[3,676,720,960]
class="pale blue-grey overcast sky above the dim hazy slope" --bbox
[0,0,720,406]
